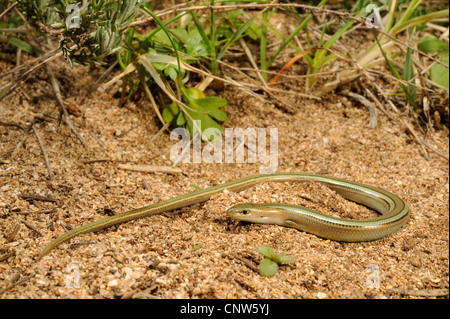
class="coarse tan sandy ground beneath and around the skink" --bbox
[0,6,449,298]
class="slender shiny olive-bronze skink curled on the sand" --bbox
[37,173,409,259]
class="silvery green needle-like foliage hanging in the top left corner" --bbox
[17,0,142,66]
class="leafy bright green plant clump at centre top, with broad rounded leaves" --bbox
[119,1,257,140]
